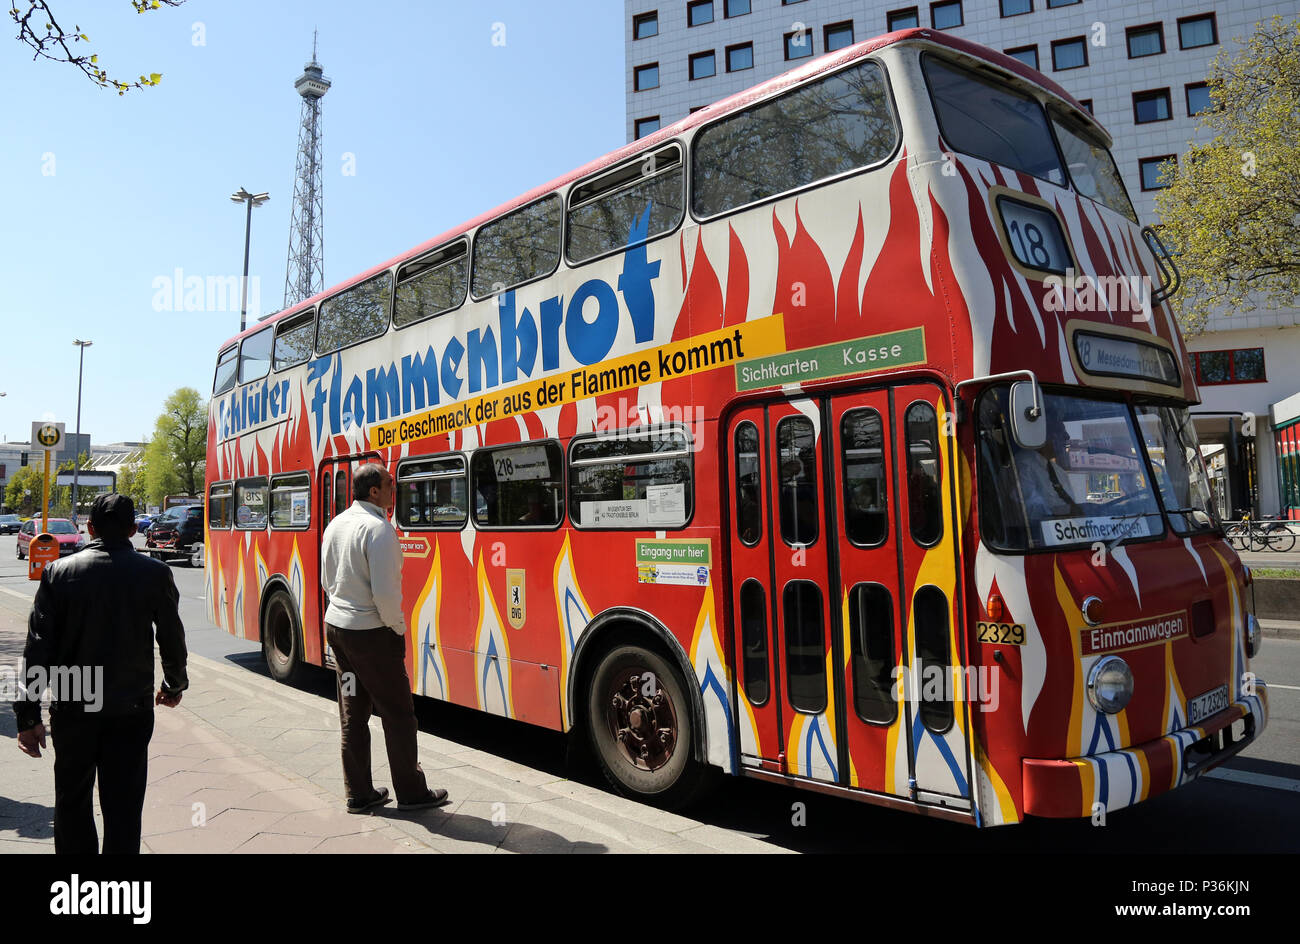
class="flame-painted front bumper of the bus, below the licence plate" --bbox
[1022,681,1269,818]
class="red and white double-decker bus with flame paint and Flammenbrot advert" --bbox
[205,30,1268,826]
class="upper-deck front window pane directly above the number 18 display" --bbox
[922,56,1065,186]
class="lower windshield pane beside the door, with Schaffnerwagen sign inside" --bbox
[979,386,1164,551]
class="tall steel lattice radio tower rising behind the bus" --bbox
[285,33,330,308]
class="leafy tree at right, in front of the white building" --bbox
[1156,17,1300,334]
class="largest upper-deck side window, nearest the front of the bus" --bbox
[692,61,898,217]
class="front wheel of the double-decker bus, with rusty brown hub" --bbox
[586,645,702,809]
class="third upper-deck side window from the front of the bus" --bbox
[472,197,564,298]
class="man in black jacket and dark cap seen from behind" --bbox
[13,494,189,854]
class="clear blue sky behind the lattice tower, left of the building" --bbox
[0,0,625,443]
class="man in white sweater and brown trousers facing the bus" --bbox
[321,463,447,813]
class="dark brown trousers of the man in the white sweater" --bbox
[325,623,429,804]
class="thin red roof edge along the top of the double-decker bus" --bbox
[220,27,1110,350]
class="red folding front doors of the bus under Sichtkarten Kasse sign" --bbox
[727,385,970,809]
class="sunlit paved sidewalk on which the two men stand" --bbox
[0,594,783,853]
